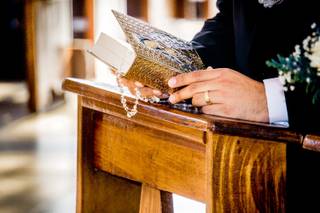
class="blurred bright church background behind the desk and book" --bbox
[0,0,217,213]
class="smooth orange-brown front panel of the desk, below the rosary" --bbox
[93,111,205,201]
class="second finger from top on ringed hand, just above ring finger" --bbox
[169,80,221,104]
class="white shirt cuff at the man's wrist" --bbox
[263,78,289,127]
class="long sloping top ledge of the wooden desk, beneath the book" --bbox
[62,78,303,144]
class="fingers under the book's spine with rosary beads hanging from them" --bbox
[120,78,168,98]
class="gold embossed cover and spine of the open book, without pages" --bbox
[112,11,204,92]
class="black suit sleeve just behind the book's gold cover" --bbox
[192,0,234,68]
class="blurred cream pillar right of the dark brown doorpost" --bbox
[36,0,72,97]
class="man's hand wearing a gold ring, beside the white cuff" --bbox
[168,68,269,122]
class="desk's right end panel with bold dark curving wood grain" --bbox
[206,133,286,213]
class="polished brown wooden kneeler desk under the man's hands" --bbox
[63,79,320,213]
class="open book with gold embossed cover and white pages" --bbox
[90,11,204,92]
